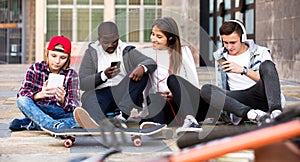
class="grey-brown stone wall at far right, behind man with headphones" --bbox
[255,0,300,82]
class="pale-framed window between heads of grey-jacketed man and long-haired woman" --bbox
[115,0,161,43]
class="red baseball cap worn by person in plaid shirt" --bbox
[47,36,72,55]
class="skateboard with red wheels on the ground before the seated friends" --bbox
[42,124,167,148]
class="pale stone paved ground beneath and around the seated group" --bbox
[0,65,300,162]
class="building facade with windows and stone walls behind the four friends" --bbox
[0,0,300,82]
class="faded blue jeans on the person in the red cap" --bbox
[17,96,76,129]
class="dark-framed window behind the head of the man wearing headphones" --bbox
[206,0,255,64]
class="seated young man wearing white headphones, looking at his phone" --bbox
[201,20,284,125]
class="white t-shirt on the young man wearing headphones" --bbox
[227,50,256,91]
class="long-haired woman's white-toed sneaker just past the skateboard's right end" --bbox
[176,115,202,135]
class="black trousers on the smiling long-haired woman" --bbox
[143,75,208,126]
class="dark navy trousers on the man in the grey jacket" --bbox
[82,74,149,123]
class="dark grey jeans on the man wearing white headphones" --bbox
[201,60,282,118]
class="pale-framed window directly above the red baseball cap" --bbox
[46,0,104,42]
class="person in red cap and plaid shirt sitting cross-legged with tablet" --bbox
[9,36,80,131]
